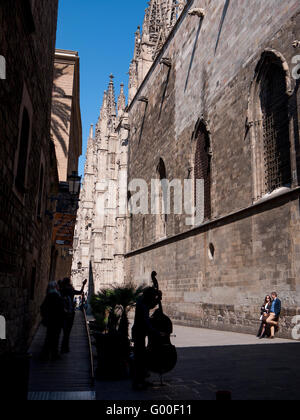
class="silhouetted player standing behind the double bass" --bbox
[132,287,163,391]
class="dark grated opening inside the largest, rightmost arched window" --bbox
[260,63,291,192]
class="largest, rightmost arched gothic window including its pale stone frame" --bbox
[249,51,292,200]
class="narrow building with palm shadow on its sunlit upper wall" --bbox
[51,49,82,281]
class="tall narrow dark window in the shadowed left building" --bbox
[16,108,30,194]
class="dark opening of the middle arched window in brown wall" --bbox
[195,126,211,220]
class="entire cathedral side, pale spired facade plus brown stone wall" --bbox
[74,0,300,337]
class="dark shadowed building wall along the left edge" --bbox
[0,0,58,353]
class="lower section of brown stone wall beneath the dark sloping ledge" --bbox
[125,194,300,338]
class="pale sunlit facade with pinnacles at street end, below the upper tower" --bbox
[73,76,129,292]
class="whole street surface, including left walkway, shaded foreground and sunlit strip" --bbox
[25,312,300,401]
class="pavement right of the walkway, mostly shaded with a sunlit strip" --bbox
[96,326,300,401]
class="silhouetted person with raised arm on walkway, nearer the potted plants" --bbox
[61,278,87,353]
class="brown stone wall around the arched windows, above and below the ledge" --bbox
[126,0,300,335]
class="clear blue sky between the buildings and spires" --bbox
[56,0,147,175]
